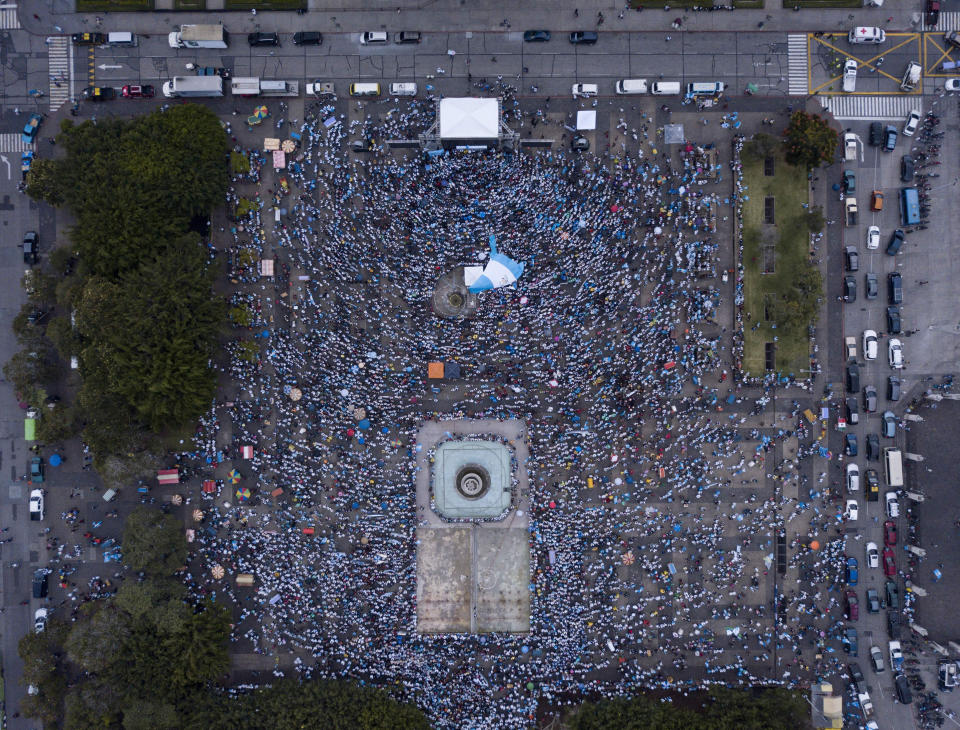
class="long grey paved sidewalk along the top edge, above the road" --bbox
[19,0,919,38]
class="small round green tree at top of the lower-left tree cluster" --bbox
[122,506,187,576]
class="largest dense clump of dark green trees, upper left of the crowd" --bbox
[15,104,228,466]
